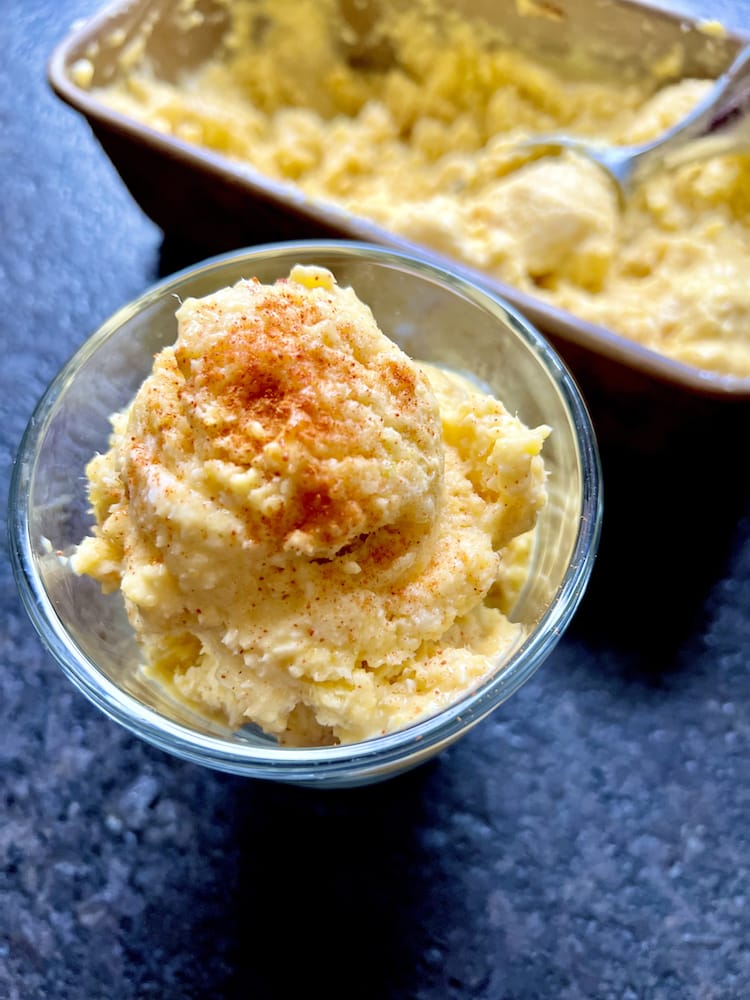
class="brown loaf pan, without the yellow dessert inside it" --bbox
[48,0,750,402]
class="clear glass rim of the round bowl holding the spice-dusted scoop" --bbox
[8,239,602,783]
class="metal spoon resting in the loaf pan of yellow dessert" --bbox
[521,46,750,197]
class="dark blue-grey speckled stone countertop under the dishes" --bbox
[0,0,750,1000]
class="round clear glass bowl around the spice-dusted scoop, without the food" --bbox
[9,240,601,786]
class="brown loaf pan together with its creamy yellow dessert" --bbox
[52,0,750,395]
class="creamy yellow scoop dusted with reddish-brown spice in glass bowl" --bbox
[72,266,548,744]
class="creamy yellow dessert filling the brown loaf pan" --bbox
[79,0,750,376]
